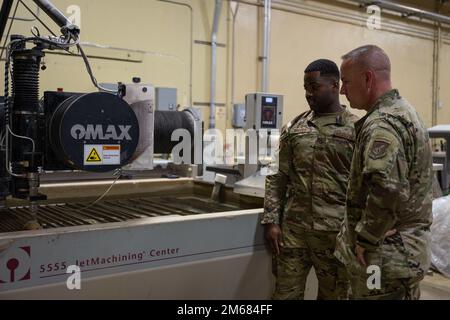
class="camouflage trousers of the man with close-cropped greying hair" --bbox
[348,272,423,300]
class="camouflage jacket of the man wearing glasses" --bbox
[262,109,357,246]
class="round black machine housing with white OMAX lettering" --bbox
[43,91,139,172]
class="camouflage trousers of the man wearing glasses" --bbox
[272,229,349,300]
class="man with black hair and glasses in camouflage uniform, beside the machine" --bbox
[262,59,357,299]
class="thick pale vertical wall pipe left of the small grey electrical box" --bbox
[209,0,222,129]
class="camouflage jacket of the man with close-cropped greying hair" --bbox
[335,90,432,278]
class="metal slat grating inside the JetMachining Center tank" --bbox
[0,196,241,232]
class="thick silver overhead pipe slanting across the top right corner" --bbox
[350,0,450,24]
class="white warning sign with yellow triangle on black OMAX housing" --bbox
[84,144,120,166]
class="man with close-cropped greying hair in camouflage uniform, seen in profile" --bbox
[335,46,432,299]
